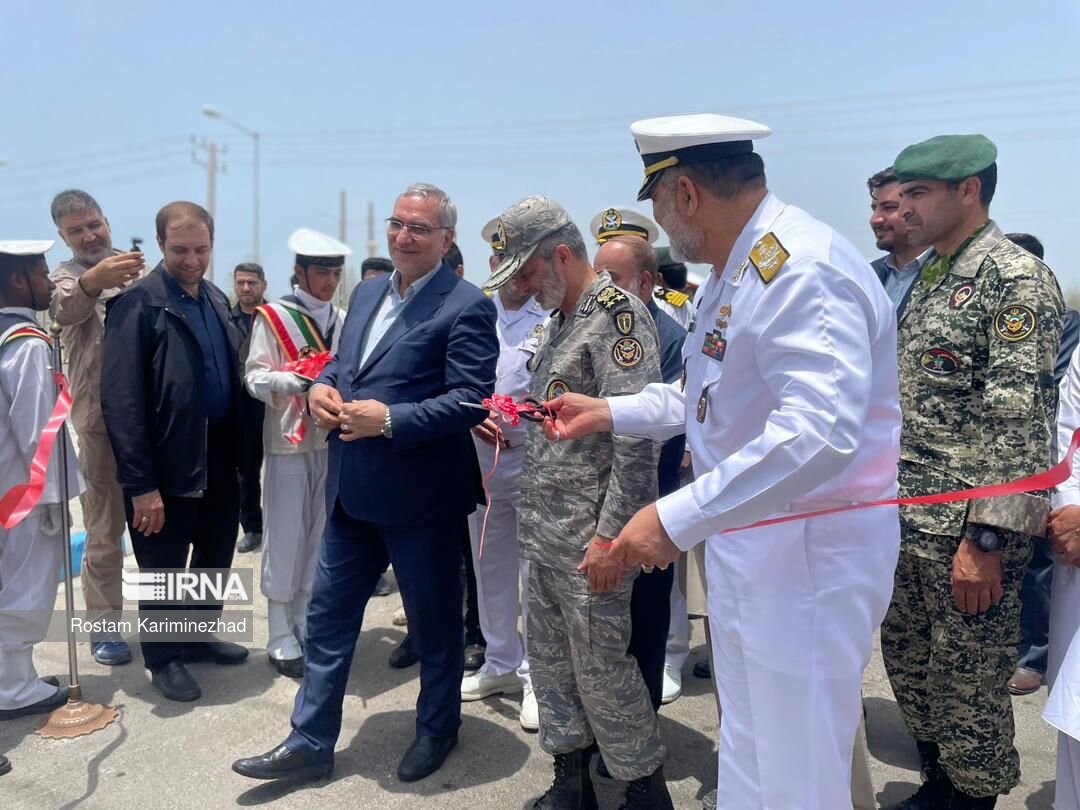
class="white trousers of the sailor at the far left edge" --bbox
[0,505,64,708]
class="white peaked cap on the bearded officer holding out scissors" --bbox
[630,112,772,200]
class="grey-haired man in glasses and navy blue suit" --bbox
[232,184,499,782]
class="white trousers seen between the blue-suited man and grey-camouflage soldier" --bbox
[469,492,532,689]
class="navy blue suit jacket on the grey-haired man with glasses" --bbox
[316,261,499,526]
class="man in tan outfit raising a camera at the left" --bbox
[49,190,146,665]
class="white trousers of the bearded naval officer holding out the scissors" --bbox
[706,508,900,810]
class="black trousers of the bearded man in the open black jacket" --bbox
[124,427,240,672]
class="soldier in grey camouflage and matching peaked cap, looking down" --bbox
[485,197,672,810]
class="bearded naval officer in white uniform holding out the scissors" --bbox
[545,114,901,810]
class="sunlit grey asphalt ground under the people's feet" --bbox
[0,529,1055,810]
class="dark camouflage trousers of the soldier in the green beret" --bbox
[881,529,1031,796]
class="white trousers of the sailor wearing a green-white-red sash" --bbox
[261,450,326,603]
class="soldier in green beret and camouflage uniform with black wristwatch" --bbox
[881,135,1064,810]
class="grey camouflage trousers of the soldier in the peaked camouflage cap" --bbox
[528,562,666,781]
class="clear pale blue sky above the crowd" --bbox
[0,0,1080,295]
